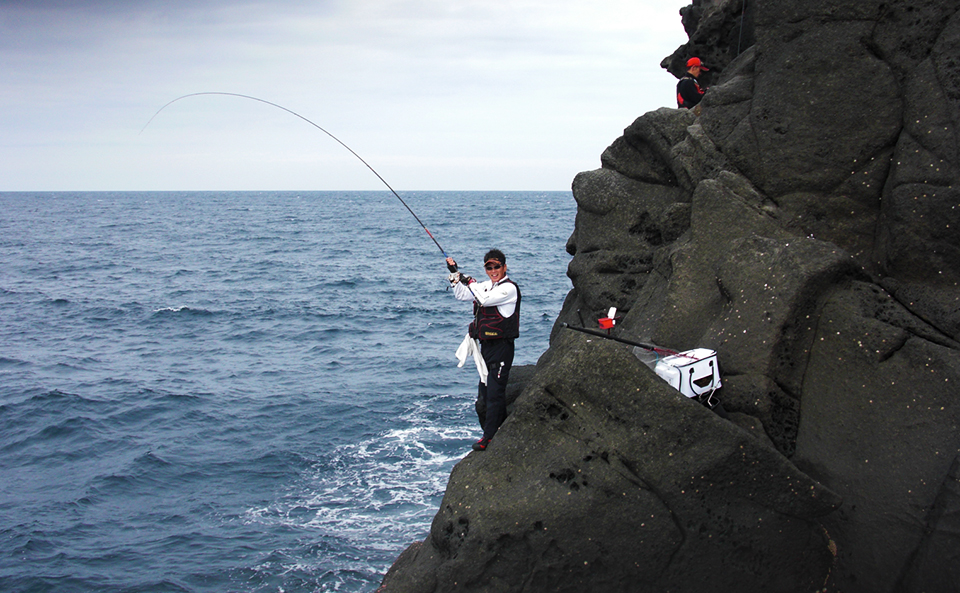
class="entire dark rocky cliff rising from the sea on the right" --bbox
[382,0,960,593]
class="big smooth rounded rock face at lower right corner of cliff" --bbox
[793,283,960,591]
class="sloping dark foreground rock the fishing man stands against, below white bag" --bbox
[383,332,839,592]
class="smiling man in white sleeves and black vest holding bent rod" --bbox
[447,249,520,451]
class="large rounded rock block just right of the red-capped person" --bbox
[736,21,902,199]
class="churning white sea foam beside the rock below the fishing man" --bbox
[245,396,476,551]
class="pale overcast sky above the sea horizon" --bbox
[0,0,690,191]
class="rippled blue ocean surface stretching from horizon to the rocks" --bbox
[0,191,576,593]
